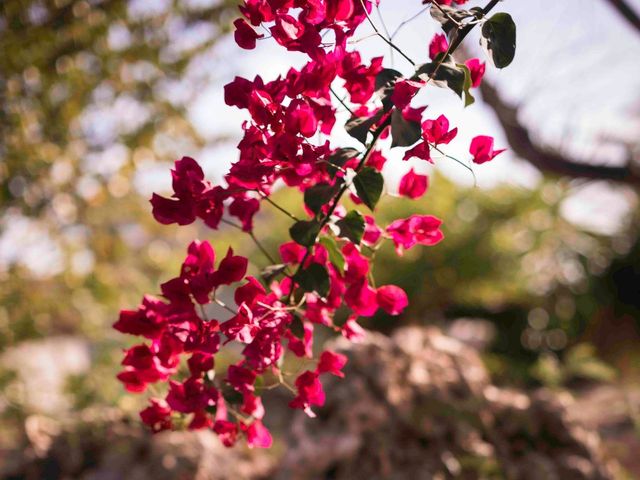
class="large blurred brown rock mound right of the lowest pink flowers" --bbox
[276,327,613,480]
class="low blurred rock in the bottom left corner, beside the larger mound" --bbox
[0,411,274,480]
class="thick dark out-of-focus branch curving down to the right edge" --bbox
[480,79,640,187]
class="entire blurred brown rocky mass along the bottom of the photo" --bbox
[0,327,618,480]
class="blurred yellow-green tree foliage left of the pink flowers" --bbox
[0,0,235,348]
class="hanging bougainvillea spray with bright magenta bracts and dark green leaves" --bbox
[114,0,510,448]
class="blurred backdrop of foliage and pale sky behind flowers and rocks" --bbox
[0,0,640,478]
